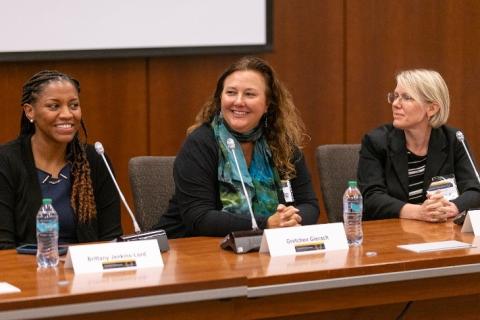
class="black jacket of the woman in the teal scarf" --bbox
[155,124,319,238]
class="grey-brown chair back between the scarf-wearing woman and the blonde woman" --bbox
[315,144,360,222]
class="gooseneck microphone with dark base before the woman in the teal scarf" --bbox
[220,138,263,253]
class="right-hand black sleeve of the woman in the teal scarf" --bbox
[291,153,319,225]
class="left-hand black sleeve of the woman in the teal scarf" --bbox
[173,126,267,236]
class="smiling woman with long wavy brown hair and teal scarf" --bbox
[157,57,319,238]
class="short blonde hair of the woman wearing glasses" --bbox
[396,69,450,128]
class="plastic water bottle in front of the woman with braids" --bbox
[37,198,59,268]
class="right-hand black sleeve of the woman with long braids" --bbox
[90,151,123,241]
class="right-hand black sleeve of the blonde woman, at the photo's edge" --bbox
[452,136,480,212]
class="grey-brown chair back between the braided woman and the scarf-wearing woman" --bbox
[128,156,175,231]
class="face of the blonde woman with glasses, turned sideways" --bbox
[392,85,438,130]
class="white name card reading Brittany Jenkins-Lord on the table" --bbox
[65,240,163,273]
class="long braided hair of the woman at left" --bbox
[19,70,97,223]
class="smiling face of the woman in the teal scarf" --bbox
[221,70,267,133]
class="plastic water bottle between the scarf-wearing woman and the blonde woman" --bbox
[343,180,363,246]
